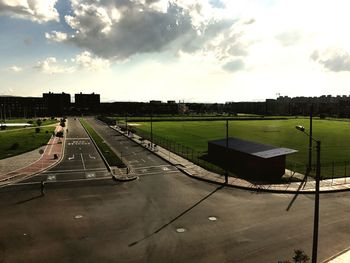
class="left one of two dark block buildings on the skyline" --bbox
[43,92,71,116]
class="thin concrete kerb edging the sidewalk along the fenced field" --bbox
[109,126,350,194]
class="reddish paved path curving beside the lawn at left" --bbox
[0,125,65,186]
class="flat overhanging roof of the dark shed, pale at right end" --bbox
[209,137,298,159]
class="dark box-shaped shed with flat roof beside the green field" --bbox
[208,138,297,180]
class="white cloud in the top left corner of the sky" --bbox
[0,0,59,23]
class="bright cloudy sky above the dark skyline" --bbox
[0,0,350,103]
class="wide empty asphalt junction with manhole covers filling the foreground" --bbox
[0,118,350,263]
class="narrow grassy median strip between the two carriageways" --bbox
[79,119,125,167]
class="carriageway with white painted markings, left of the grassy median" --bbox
[22,118,110,182]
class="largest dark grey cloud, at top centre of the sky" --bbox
[46,0,254,63]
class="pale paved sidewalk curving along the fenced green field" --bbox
[111,126,350,193]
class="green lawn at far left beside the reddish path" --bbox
[0,126,55,159]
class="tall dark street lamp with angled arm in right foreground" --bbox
[295,125,321,263]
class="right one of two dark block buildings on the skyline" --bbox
[74,92,100,113]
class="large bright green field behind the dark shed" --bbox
[134,118,350,177]
